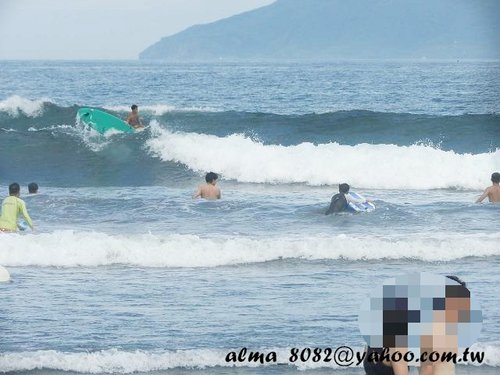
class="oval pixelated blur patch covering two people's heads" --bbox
[358,273,482,355]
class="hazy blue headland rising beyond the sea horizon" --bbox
[139,0,500,61]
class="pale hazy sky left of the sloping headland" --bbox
[0,0,274,59]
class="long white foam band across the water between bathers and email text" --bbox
[0,231,500,267]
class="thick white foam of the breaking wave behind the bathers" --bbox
[147,127,500,189]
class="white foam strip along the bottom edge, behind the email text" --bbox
[0,343,500,374]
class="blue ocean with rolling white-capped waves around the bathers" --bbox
[0,61,500,375]
